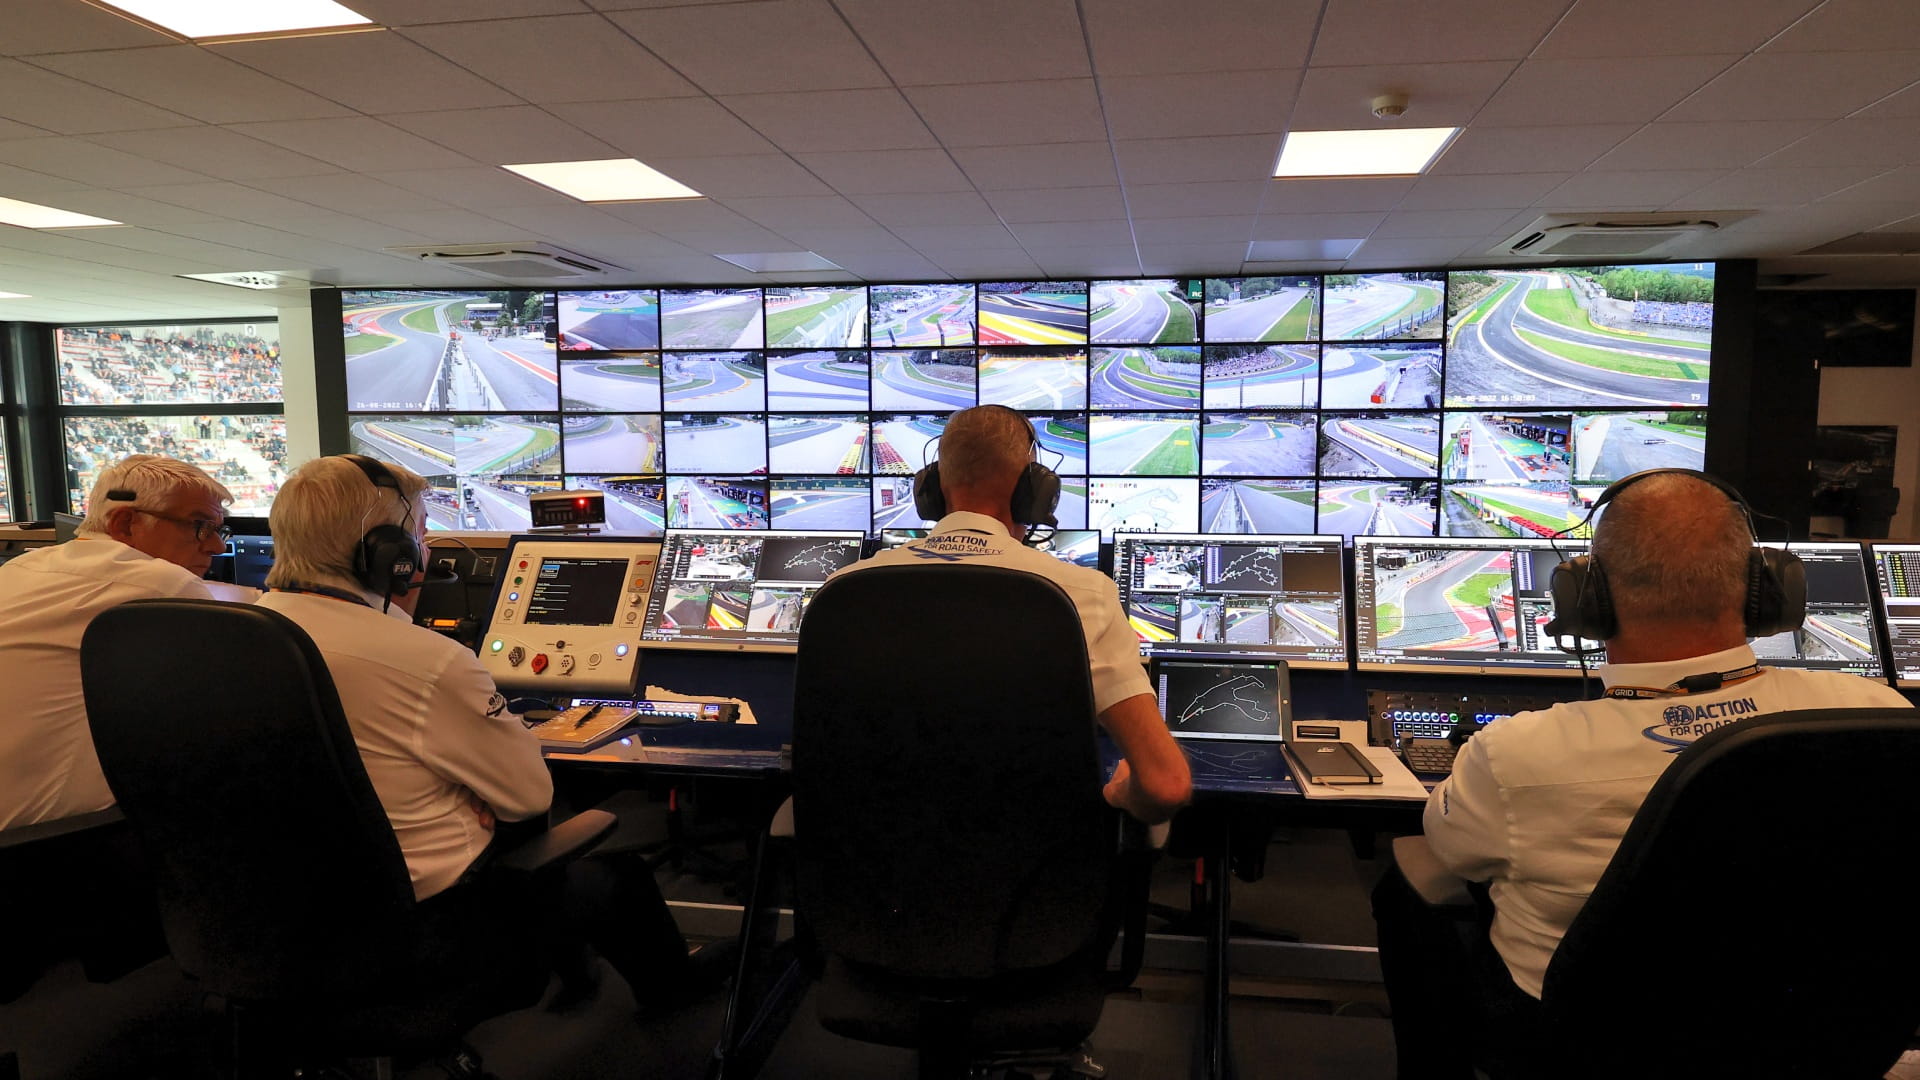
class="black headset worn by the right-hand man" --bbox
[1546,469,1807,642]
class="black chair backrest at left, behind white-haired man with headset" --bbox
[81,600,413,999]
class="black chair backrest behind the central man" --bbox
[793,565,1117,978]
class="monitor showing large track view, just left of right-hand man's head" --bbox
[1354,536,1594,675]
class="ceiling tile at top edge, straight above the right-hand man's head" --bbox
[1534,0,1820,58]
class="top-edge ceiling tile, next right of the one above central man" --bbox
[1081,0,1319,79]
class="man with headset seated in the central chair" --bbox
[841,405,1192,822]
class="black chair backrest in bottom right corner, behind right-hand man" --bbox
[1542,709,1920,1078]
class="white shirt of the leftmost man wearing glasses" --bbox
[0,536,207,828]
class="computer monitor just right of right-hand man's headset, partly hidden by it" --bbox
[1753,542,1887,678]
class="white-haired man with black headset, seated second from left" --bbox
[259,454,712,1005]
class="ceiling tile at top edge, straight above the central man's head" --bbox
[837,0,1092,86]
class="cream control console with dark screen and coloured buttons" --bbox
[480,536,660,698]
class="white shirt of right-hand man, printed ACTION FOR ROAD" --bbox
[1427,646,1908,997]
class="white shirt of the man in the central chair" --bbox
[839,511,1154,715]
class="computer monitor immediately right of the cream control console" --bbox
[641,528,866,651]
